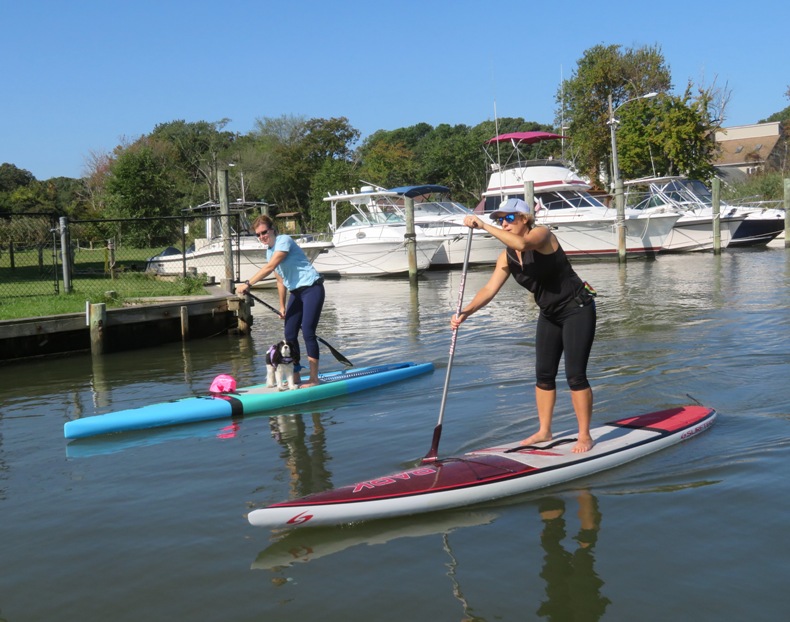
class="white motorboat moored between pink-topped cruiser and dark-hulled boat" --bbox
[624,177,747,253]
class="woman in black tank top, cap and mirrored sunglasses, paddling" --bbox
[450,199,596,453]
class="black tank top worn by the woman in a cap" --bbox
[507,241,584,315]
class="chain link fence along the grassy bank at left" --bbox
[0,213,249,301]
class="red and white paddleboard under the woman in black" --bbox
[247,406,716,528]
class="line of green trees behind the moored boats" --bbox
[0,45,790,246]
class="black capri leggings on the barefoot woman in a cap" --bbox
[535,301,596,391]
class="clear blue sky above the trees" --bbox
[0,0,790,180]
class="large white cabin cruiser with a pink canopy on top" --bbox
[475,132,680,258]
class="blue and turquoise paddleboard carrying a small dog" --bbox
[63,363,433,439]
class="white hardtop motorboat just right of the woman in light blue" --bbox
[313,186,447,276]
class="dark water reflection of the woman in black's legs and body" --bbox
[536,490,611,621]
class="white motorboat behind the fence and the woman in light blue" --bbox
[146,201,332,287]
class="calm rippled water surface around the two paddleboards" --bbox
[0,249,790,622]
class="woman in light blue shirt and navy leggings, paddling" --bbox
[236,215,326,387]
